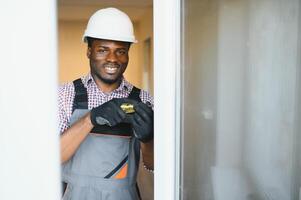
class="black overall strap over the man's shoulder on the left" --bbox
[72,78,88,112]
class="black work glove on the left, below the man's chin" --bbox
[91,98,126,126]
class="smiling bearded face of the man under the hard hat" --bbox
[87,40,130,84]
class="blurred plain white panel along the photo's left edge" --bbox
[0,0,60,200]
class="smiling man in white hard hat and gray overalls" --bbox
[59,8,153,200]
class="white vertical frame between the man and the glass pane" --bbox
[153,0,181,200]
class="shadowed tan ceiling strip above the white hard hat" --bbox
[58,0,153,22]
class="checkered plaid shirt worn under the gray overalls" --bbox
[58,73,154,133]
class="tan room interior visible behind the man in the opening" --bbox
[58,0,154,200]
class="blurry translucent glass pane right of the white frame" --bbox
[182,0,301,200]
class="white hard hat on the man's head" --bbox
[83,8,137,43]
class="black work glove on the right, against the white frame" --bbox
[132,102,154,143]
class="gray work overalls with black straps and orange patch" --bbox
[62,79,140,200]
